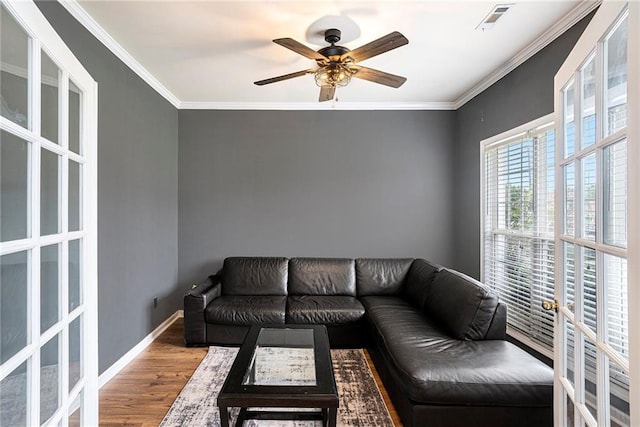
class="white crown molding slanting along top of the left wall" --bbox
[59,0,180,108]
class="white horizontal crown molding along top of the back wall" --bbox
[178,102,455,110]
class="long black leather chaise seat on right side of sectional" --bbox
[363,297,553,407]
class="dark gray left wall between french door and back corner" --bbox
[37,1,182,372]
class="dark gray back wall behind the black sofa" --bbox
[178,110,455,287]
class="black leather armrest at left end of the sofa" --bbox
[184,275,222,346]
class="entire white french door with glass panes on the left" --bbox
[0,0,98,426]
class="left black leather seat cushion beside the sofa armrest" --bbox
[205,295,287,326]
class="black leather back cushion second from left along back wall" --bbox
[289,258,356,297]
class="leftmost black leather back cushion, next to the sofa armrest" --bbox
[221,257,288,295]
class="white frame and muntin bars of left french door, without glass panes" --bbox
[0,0,98,426]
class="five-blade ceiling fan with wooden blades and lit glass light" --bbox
[254,28,409,102]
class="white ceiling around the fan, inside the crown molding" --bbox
[63,0,593,108]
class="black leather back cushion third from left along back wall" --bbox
[356,258,413,296]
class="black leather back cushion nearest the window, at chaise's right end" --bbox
[424,269,498,340]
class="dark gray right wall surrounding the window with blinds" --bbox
[454,14,593,278]
